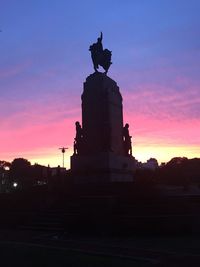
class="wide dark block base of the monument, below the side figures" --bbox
[71,152,135,183]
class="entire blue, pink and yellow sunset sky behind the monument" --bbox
[0,0,200,167]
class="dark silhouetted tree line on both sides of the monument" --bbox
[0,157,200,193]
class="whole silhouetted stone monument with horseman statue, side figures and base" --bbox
[71,33,135,183]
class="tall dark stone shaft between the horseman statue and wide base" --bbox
[82,73,124,155]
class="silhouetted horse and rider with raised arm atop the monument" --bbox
[89,32,112,74]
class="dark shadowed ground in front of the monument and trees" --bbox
[0,185,200,267]
